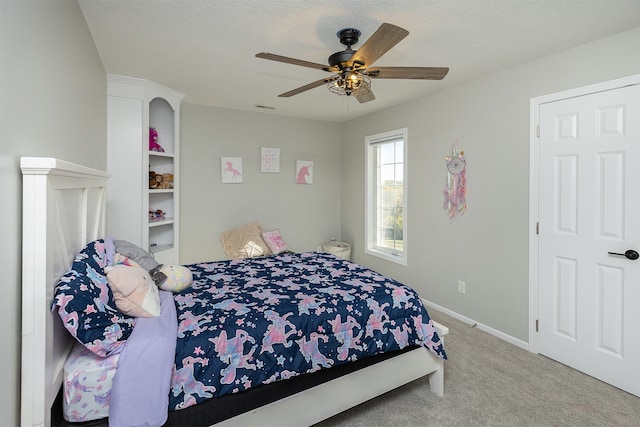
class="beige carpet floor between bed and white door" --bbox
[316,309,640,427]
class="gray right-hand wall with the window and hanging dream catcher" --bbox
[342,28,640,341]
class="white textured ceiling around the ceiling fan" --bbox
[79,0,640,122]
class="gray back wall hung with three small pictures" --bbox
[180,104,342,263]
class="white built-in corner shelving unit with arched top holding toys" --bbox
[107,74,184,264]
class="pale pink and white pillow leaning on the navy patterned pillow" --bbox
[105,255,160,317]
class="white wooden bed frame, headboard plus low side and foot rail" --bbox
[20,157,449,426]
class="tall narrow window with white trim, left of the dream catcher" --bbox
[365,128,407,265]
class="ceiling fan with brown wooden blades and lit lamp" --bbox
[256,23,449,103]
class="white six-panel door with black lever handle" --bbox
[538,85,640,396]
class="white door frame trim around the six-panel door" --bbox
[529,74,640,353]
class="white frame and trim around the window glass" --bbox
[365,128,408,266]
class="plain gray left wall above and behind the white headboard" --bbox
[0,0,106,426]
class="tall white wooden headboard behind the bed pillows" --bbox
[20,157,109,426]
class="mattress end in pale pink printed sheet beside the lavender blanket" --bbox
[62,343,120,422]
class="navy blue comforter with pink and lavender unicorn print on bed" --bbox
[169,252,446,410]
